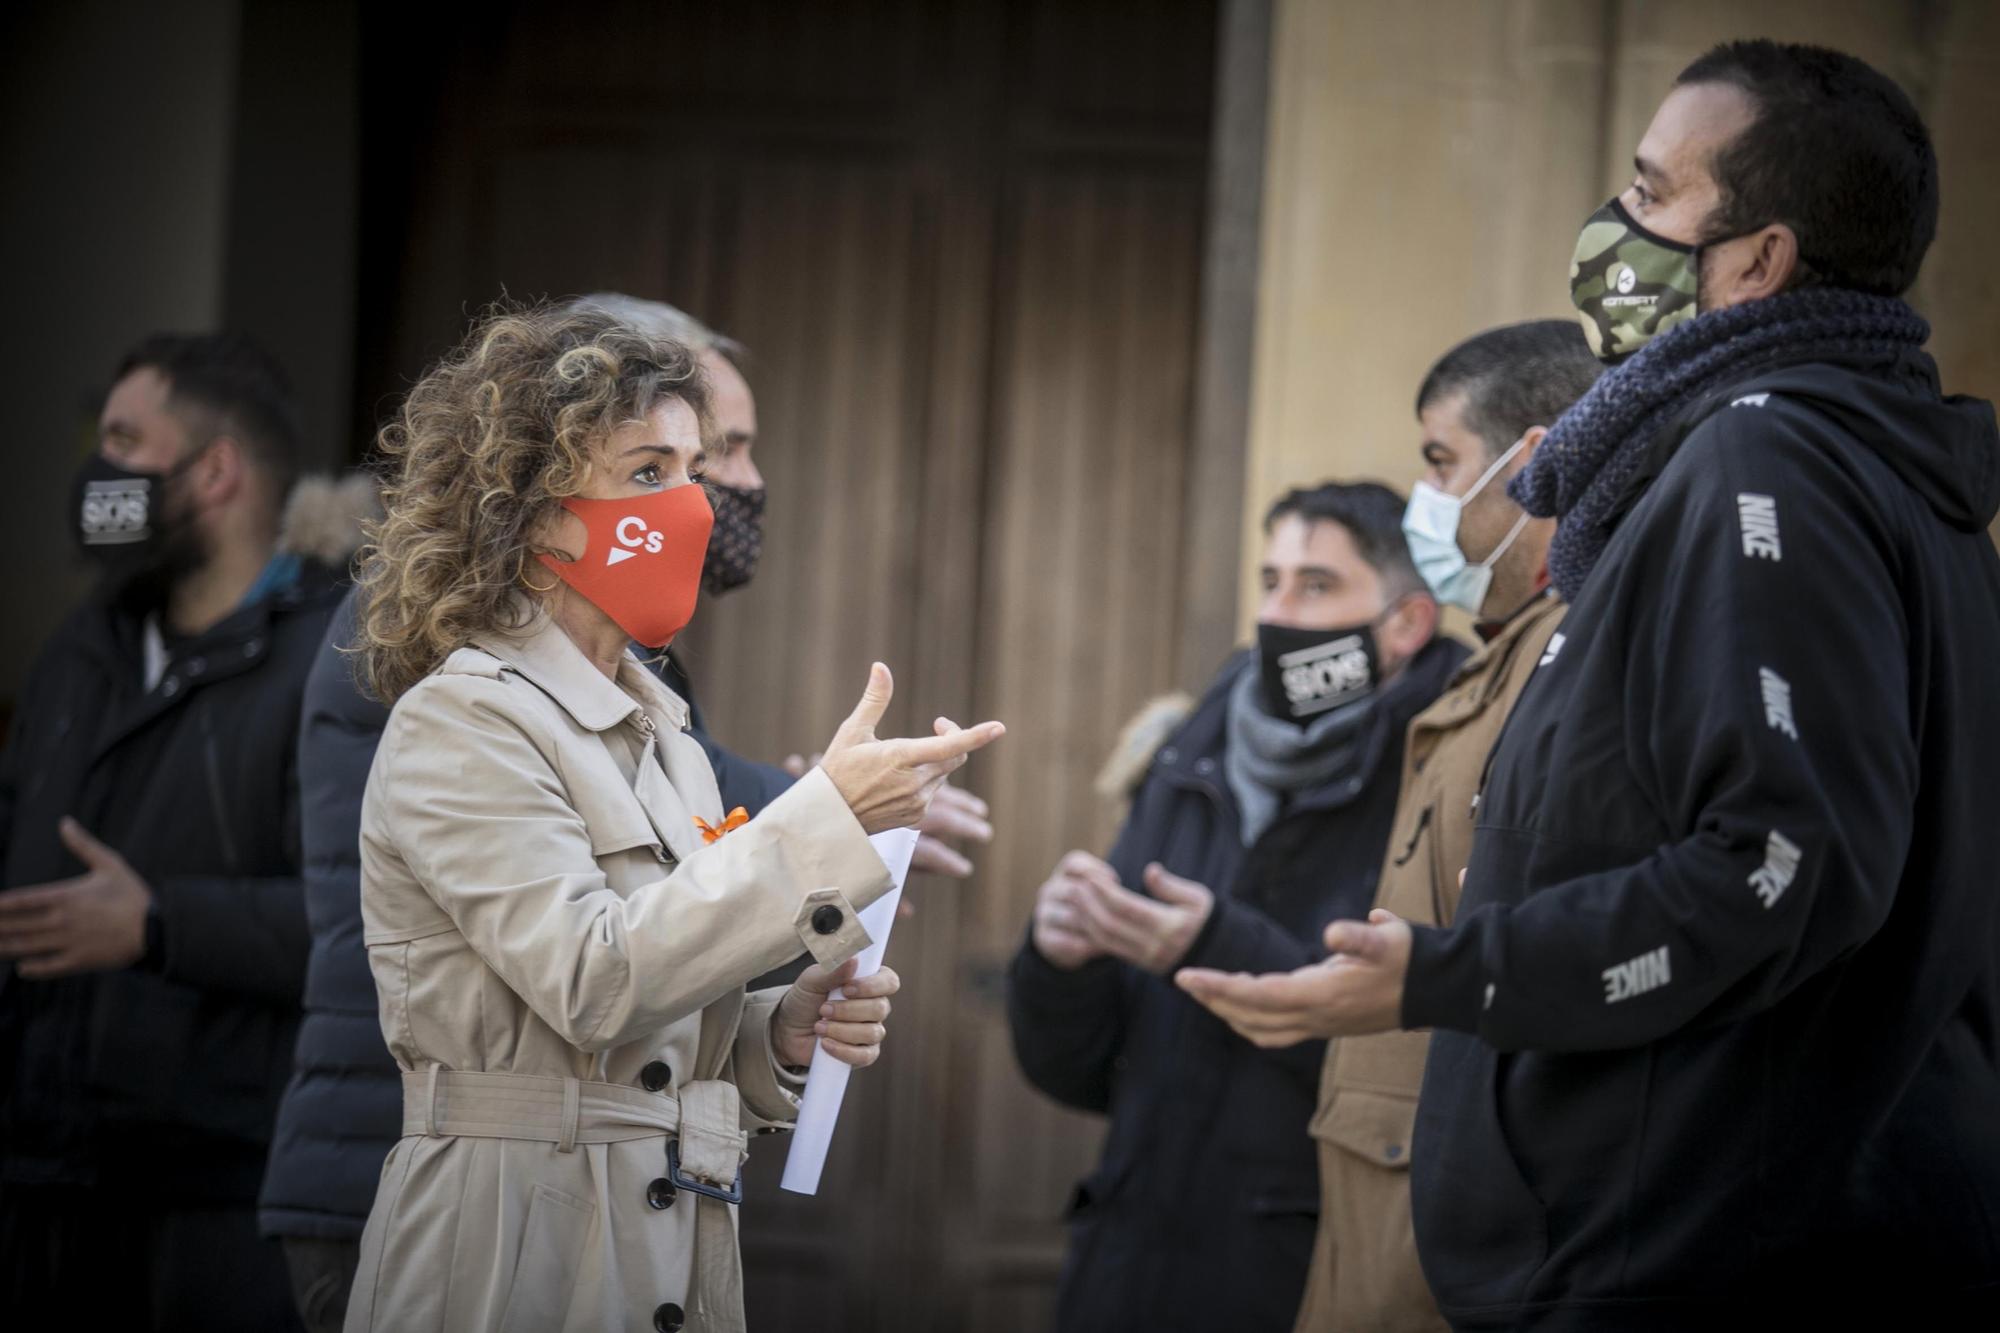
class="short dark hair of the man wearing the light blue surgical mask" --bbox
[1416,320,1604,458]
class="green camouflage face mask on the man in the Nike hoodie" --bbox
[1570,198,1698,362]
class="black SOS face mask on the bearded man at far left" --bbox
[70,452,202,602]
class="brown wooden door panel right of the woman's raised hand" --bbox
[946,168,1200,1327]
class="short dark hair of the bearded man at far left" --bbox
[112,332,302,498]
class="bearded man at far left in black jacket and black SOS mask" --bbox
[0,334,354,1329]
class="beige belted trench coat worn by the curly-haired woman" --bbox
[346,616,888,1333]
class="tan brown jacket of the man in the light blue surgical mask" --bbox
[1298,596,1566,1333]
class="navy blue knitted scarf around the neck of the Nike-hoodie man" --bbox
[1508,288,1930,602]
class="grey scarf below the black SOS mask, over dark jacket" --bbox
[1222,664,1382,847]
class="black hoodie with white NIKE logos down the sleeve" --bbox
[1402,352,2000,1329]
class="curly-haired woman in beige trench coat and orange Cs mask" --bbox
[346,306,1002,1333]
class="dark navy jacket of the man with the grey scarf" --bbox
[1008,638,1466,1333]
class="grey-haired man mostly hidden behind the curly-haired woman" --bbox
[258,292,992,1333]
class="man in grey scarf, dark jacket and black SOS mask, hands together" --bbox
[1008,482,1466,1333]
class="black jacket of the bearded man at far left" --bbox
[0,548,340,1203]
